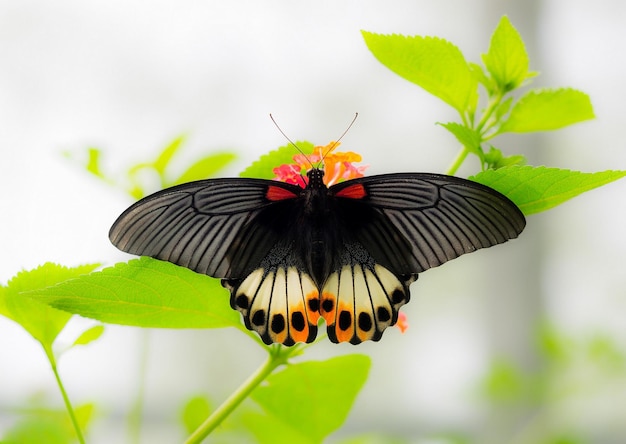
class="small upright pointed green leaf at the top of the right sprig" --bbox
[482,16,534,93]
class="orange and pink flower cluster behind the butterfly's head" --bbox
[273,142,367,188]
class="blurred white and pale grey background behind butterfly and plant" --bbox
[0,0,626,444]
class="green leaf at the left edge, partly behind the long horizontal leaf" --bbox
[0,263,99,350]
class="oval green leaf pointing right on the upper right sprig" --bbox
[498,88,594,133]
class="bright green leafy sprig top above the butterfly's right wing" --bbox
[363,16,594,174]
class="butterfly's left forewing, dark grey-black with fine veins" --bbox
[109,179,301,278]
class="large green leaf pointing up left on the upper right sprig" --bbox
[361,31,478,113]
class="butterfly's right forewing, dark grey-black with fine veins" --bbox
[329,173,525,274]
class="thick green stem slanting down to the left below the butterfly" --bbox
[185,346,298,444]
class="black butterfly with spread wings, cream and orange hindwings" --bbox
[109,161,526,345]
